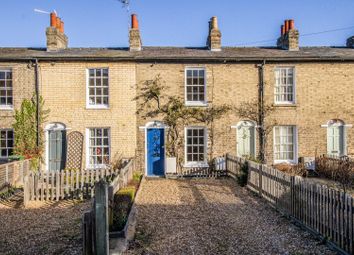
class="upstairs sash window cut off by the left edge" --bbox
[0,70,13,109]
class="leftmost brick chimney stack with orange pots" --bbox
[46,12,68,51]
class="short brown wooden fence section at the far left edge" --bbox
[0,159,31,191]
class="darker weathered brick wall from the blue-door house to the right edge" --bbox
[137,63,354,168]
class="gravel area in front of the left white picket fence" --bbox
[0,191,90,255]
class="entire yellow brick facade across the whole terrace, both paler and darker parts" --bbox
[0,61,354,170]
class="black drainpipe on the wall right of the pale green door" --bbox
[257,60,266,164]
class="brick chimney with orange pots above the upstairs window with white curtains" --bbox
[277,19,299,51]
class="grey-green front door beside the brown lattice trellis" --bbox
[48,130,66,171]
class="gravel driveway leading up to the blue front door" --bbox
[126,179,335,254]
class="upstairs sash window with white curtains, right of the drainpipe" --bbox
[274,67,295,104]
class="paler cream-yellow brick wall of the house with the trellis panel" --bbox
[40,62,136,169]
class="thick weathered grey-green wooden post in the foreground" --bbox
[95,180,109,255]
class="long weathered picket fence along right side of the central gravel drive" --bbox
[226,154,354,254]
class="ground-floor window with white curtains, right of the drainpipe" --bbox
[274,126,296,163]
